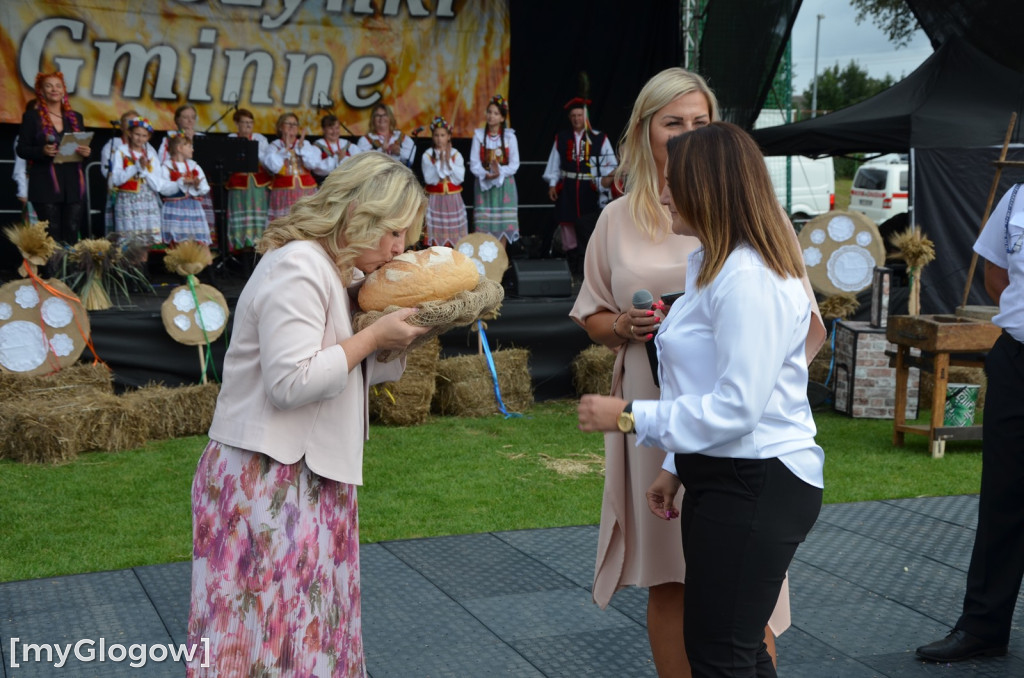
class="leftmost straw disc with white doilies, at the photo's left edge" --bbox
[0,279,90,376]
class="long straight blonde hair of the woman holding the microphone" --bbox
[615,68,718,238]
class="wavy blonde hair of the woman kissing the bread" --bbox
[264,153,427,285]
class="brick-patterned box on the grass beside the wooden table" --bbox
[834,321,921,419]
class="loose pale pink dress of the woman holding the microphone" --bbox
[569,198,823,635]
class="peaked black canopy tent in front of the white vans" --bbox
[752,35,1024,313]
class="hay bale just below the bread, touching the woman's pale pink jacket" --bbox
[370,337,441,426]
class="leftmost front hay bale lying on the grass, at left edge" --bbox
[0,389,148,464]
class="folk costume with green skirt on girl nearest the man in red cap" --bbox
[469,110,519,248]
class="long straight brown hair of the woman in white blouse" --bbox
[668,122,804,288]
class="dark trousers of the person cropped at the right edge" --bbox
[956,332,1024,644]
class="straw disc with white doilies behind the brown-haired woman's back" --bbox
[799,211,886,296]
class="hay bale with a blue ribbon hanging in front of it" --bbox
[433,348,534,417]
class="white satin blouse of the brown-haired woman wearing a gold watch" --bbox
[633,246,824,488]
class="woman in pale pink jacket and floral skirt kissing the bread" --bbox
[187,154,428,678]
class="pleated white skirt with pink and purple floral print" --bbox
[187,440,366,678]
